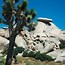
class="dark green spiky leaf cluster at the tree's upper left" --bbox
[2,2,12,20]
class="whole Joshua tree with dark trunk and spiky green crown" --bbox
[0,0,36,65]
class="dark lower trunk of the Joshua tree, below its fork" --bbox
[5,33,16,65]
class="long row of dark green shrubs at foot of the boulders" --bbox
[23,51,54,61]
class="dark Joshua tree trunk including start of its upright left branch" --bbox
[5,22,16,65]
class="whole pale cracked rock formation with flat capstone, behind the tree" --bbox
[0,18,65,62]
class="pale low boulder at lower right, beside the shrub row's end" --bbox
[47,49,65,63]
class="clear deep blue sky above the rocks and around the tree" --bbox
[0,0,65,30]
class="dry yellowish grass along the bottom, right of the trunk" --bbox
[12,57,65,65]
